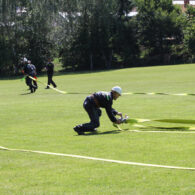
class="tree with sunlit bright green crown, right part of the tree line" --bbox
[137,0,182,64]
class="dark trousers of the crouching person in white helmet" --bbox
[79,97,101,132]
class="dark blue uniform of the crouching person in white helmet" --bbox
[74,91,118,134]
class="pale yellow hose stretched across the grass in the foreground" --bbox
[0,146,195,171]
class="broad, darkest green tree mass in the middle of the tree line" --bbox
[62,0,138,70]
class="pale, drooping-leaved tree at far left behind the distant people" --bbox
[0,0,59,74]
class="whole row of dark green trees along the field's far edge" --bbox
[0,0,195,74]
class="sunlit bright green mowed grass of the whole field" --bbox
[0,64,195,195]
